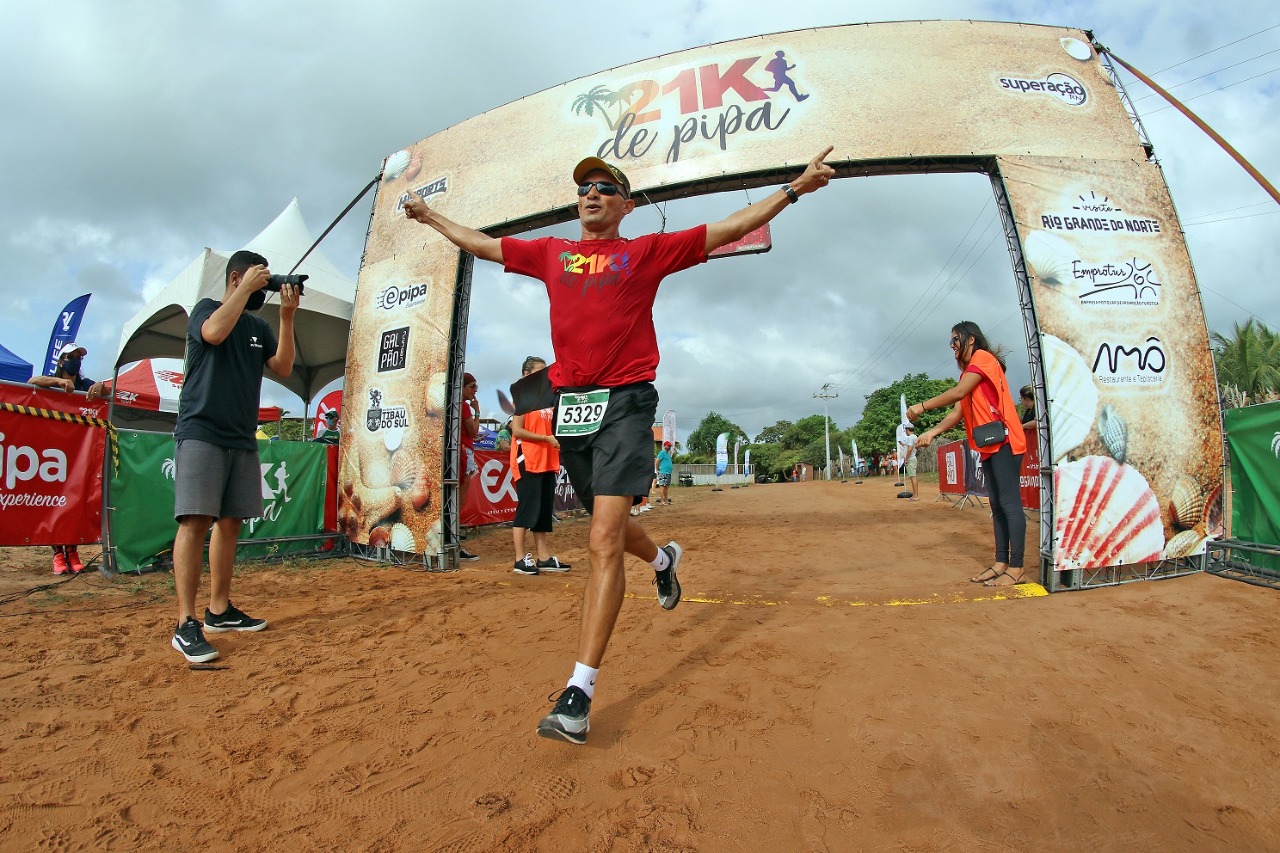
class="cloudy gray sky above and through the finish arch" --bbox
[0,0,1280,437]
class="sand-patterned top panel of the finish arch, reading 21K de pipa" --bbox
[369,20,1146,261]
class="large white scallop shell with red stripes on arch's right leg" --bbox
[1053,456,1165,570]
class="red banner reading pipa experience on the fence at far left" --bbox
[0,384,106,546]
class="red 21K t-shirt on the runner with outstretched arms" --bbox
[502,225,707,388]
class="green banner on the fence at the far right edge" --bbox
[1225,402,1280,570]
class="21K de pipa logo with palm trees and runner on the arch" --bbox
[570,50,809,163]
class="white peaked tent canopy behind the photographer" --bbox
[115,199,356,403]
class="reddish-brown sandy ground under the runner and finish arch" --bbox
[0,479,1280,853]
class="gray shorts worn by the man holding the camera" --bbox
[173,438,262,519]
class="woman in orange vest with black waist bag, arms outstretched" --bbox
[906,320,1027,587]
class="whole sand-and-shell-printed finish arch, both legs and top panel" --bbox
[339,22,1222,585]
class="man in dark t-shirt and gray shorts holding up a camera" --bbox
[170,251,305,663]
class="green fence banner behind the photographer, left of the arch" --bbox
[109,429,326,571]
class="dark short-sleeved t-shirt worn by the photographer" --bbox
[173,300,276,450]
